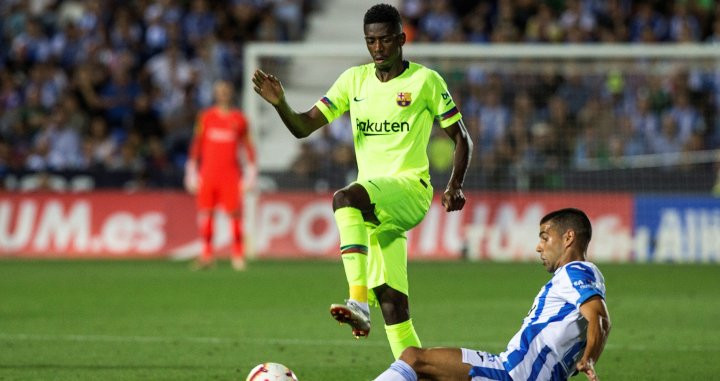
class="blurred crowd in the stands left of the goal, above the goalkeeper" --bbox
[0,0,312,188]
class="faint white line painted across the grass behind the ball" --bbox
[0,332,718,352]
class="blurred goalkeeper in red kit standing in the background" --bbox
[184,81,257,270]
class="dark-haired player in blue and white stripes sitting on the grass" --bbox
[375,208,610,381]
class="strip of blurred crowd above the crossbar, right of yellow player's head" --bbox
[401,0,720,44]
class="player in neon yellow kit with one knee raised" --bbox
[253,4,472,358]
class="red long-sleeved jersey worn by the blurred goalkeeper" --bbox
[190,107,255,177]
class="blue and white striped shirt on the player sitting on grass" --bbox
[500,261,605,381]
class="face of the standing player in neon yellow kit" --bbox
[365,23,405,71]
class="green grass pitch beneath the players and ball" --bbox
[0,260,720,381]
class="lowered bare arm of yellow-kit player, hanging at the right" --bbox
[442,119,473,212]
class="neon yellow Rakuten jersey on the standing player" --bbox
[315,62,462,180]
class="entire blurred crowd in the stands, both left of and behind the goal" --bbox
[0,0,720,188]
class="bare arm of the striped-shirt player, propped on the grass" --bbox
[577,296,610,381]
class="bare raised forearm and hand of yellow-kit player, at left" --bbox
[253,69,328,139]
